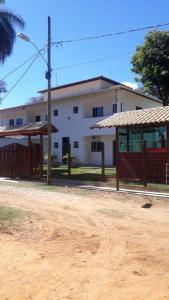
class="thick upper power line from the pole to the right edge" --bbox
[52,23,169,46]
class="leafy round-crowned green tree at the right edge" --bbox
[131,30,169,106]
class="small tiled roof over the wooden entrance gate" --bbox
[0,122,58,137]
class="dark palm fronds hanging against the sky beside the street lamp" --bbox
[0,0,25,63]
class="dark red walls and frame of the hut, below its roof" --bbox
[116,122,169,185]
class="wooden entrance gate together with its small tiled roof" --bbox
[0,122,58,179]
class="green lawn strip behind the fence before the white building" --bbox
[44,165,116,181]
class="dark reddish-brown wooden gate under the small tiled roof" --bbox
[0,143,42,179]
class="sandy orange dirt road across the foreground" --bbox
[0,186,169,300]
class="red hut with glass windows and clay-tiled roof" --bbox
[91,106,169,185]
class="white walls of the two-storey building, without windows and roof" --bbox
[0,80,161,165]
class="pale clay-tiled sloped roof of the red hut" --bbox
[91,106,169,129]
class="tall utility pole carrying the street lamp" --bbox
[46,17,52,185]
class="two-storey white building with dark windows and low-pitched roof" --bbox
[0,76,162,166]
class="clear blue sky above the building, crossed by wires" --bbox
[0,0,169,108]
